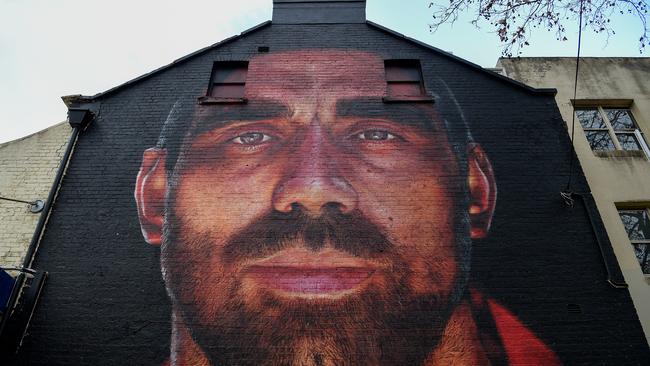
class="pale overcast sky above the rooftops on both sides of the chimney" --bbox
[0,0,639,142]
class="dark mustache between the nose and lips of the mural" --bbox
[222,204,394,264]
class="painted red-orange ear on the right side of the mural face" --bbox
[467,143,497,239]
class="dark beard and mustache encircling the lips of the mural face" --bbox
[163,208,464,365]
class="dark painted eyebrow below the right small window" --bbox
[336,97,440,131]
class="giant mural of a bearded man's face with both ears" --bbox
[136,50,495,365]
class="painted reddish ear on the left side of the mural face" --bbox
[134,148,167,245]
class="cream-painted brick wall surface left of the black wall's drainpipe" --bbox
[0,122,71,267]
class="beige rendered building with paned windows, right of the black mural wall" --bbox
[497,57,650,339]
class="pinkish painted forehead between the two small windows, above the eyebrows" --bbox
[246,50,386,99]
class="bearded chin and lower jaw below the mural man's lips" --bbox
[176,282,448,365]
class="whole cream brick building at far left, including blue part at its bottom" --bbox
[0,122,70,352]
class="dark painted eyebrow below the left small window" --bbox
[189,101,290,136]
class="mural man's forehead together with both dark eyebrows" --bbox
[184,49,439,136]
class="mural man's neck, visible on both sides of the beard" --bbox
[170,301,490,366]
